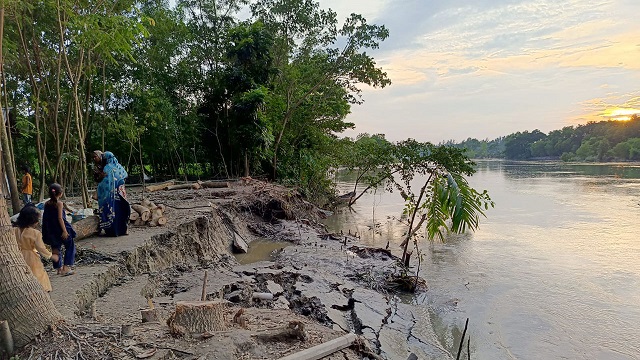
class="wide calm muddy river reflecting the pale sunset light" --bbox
[327,160,640,360]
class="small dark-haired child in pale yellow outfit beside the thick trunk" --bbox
[15,205,59,292]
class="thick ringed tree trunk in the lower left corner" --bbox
[0,187,62,347]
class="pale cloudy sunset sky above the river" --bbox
[319,0,640,143]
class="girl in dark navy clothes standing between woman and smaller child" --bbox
[42,183,76,275]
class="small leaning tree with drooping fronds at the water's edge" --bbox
[388,139,494,272]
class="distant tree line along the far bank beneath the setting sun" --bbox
[445,115,640,162]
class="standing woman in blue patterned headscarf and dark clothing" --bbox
[93,151,131,236]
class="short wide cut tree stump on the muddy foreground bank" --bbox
[167,300,226,334]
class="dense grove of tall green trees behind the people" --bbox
[2,0,390,201]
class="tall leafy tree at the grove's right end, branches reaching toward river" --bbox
[251,0,391,179]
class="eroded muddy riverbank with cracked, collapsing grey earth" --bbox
[13,180,450,359]
